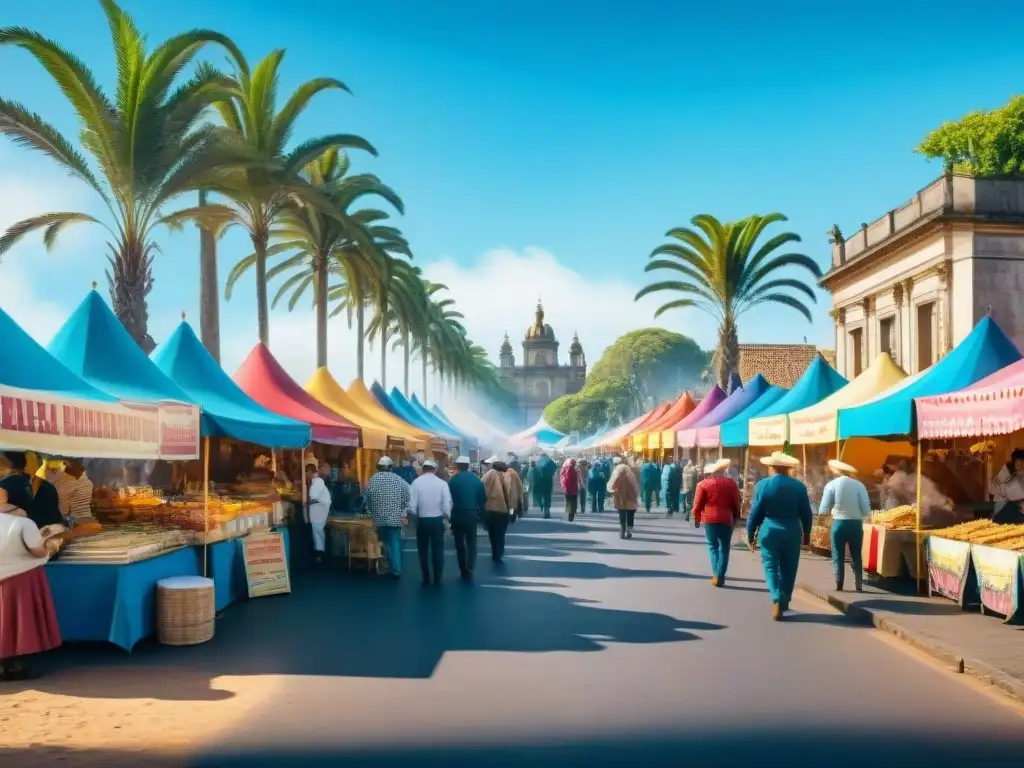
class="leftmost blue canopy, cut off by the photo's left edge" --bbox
[0,309,117,402]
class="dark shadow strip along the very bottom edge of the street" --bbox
[8,725,1024,768]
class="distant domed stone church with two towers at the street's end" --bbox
[498,302,587,427]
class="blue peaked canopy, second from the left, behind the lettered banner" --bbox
[48,290,197,406]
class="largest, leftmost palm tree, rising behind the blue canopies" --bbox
[0,0,251,352]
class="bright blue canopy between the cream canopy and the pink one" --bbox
[839,317,1021,439]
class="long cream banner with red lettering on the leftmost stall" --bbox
[0,385,200,461]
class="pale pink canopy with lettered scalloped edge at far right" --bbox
[913,359,1024,439]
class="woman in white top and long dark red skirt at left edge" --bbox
[0,488,60,682]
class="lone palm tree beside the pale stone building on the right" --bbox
[636,213,821,387]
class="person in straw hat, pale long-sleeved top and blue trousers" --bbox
[818,459,871,592]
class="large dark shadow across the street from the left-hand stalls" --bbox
[24,557,724,700]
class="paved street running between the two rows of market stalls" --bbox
[0,514,1024,766]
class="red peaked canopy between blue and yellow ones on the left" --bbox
[234,343,359,446]
